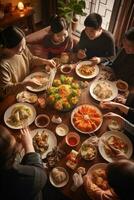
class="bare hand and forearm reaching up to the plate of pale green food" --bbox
[20,128,35,153]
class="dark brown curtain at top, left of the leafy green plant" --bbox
[42,0,58,26]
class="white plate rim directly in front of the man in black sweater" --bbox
[75,61,99,79]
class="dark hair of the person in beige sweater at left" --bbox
[0,26,25,49]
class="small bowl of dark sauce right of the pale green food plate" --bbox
[35,114,50,128]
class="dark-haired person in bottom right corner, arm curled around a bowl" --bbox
[84,156,134,200]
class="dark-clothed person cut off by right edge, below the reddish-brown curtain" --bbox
[111,27,134,86]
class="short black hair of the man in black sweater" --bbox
[84,13,102,30]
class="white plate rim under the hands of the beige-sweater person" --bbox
[24,72,49,92]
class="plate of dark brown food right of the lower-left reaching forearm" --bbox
[31,128,57,159]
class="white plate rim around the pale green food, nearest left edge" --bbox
[4,103,36,129]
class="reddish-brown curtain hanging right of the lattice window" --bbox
[113,0,134,48]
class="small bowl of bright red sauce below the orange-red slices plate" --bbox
[65,132,80,147]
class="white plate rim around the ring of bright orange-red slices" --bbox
[71,104,103,134]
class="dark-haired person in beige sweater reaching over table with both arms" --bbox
[0,26,55,97]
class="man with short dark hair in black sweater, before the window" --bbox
[76,13,115,64]
